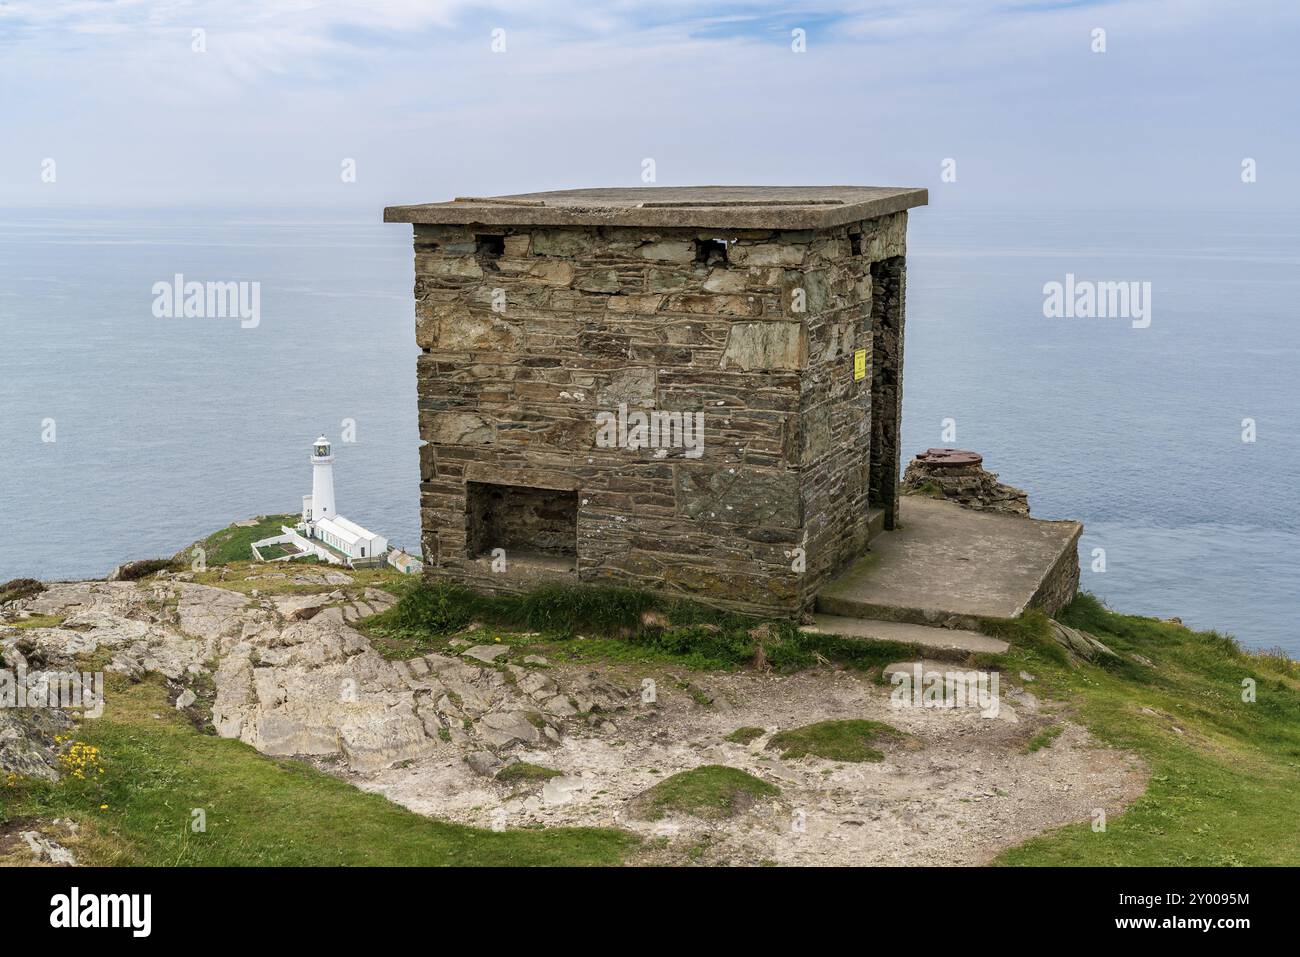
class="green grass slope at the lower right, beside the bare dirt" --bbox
[998,596,1300,866]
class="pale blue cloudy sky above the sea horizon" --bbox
[0,0,1300,215]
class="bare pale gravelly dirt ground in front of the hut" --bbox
[345,667,1147,865]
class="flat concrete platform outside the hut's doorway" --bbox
[816,495,1083,628]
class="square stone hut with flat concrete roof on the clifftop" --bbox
[384,186,927,615]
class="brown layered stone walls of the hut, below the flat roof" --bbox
[415,213,906,614]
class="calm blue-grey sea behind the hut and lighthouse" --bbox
[0,207,1300,657]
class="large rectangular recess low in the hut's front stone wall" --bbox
[465,482,577,568]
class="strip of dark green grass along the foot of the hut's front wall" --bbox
[364,581,920,672]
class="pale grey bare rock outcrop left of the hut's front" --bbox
[0,570,636,778]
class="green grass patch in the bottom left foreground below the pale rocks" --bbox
[0,676,638,866]
